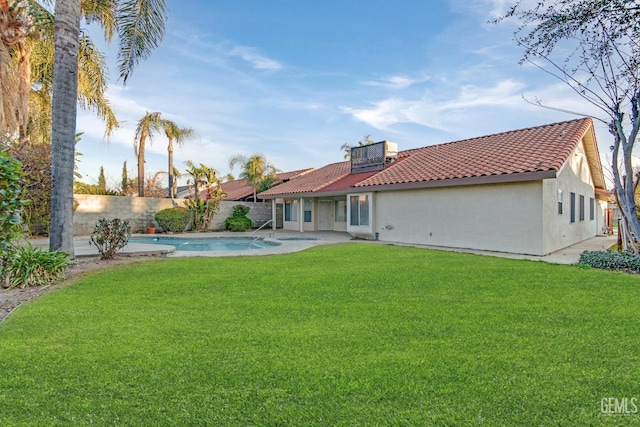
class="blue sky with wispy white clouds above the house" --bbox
[72,0,610,186]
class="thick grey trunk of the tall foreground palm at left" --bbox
[49,0,80,257]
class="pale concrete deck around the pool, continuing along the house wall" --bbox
[31,230,617,264]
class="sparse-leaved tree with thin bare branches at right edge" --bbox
[495,0,640,251]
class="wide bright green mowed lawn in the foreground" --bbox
[0,243,640,426]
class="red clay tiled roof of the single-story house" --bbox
[261,118,603,198]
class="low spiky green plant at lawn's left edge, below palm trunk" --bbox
[4,244,74,288]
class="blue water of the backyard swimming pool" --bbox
[129,236,280,251]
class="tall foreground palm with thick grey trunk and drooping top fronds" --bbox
[49,0,167,257]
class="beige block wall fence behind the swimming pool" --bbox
[73,194,282,236]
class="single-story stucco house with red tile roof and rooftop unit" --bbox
[260,118,609,255]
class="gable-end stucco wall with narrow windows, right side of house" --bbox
[543,142,603,254]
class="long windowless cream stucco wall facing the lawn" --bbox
[375,181,543,255]
